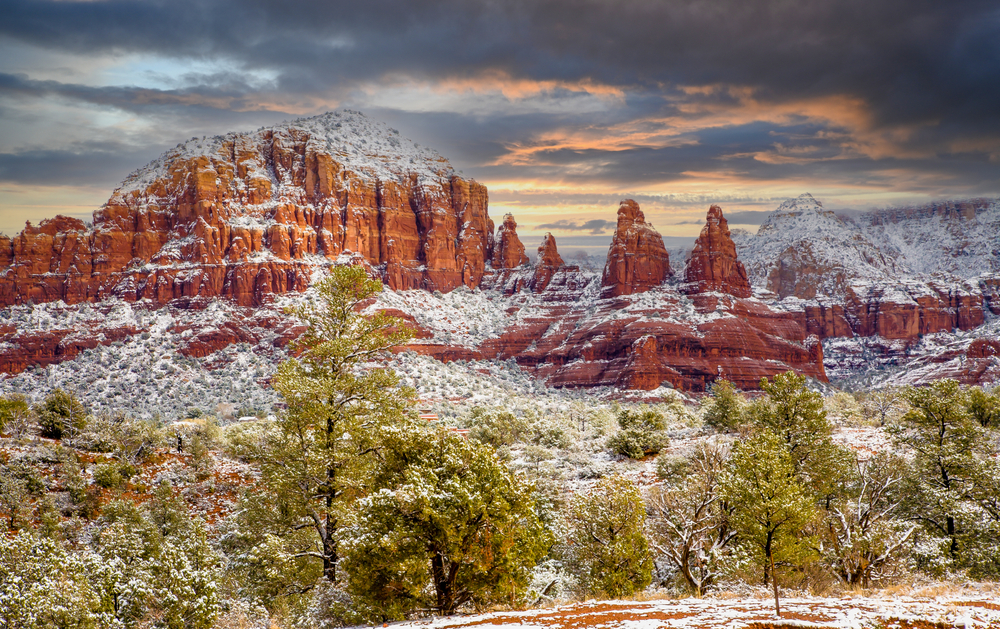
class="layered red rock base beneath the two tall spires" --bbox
[476,276,826,391]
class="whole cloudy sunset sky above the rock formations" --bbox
[0,0,1000,251]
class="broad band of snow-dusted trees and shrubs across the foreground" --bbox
[0,268,1000,628]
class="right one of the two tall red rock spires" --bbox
[684,205,753,297]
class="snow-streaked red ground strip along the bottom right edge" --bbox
[392,593,1000,629]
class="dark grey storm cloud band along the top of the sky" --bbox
[7,0,1000,137]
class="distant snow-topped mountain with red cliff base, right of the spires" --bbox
[737,194,1000,340]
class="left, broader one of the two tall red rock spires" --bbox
[601,199,673,296]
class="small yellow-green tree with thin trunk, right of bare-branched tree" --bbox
[719,430,815,616]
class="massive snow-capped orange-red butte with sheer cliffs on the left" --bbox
[0,112,493,305]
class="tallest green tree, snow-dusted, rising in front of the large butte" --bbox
[227,266,412,605]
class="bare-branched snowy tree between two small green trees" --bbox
[647,443,735,596]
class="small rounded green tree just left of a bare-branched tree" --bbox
[568,476,653,598]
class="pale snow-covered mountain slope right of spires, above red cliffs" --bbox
[733,194,1000,299]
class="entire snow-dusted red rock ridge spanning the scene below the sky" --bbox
[0,112,1000,402]
